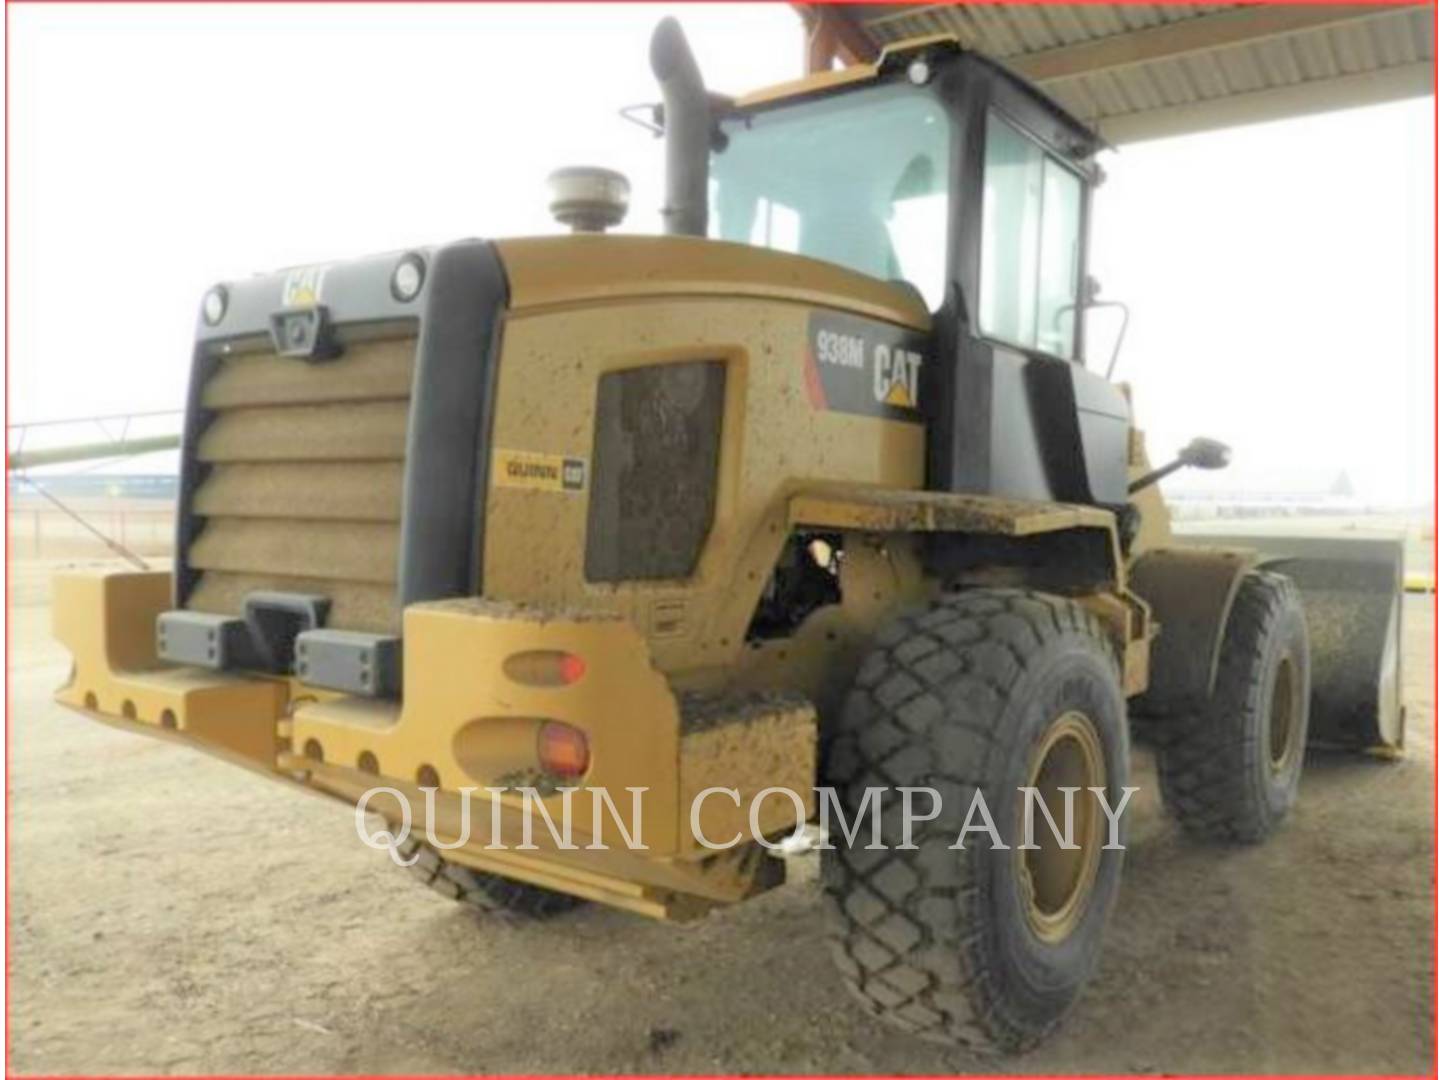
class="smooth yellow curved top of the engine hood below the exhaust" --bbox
[495,235,930,331]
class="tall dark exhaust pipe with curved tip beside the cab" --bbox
[649,16,711,236]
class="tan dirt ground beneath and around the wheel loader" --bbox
[10,561,1434,1074]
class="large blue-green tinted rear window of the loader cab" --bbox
[710,85,950,310]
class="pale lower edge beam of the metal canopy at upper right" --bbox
[1100,60,1434,145]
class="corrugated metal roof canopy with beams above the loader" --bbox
[795,3,1436,145]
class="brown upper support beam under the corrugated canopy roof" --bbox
[1005,3,1414,84]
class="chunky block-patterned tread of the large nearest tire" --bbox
[822,589,1119,1051]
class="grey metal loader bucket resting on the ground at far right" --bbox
[1182,533,1405,750]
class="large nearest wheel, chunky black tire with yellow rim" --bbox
[822,589,1129,1051]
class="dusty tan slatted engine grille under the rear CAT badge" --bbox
[186,337,416,634]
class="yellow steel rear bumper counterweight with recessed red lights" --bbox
[55,572,815,916]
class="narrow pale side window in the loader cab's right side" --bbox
[979,112,1081,360]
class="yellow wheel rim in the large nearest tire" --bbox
[1015,711,1107,943]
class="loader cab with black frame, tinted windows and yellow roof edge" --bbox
[708,39,1129,507]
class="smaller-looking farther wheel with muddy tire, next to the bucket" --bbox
[1156,570,1310,844]
